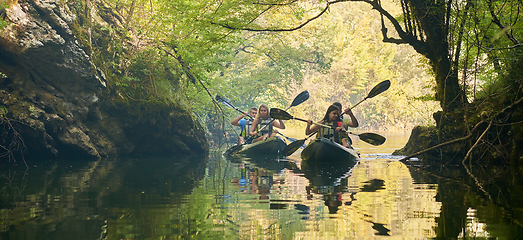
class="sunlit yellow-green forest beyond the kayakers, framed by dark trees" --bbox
[64,1,439,142]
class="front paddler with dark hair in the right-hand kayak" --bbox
[305,105,351,148]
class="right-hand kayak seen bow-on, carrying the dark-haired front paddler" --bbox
[301,138,359,166]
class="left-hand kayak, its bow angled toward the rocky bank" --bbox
[229,136,287,156]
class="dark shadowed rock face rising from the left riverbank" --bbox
[0,0,208,159]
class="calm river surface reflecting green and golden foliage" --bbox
[0,134,523,240]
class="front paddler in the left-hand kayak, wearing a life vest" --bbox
[249,103,285,143]
